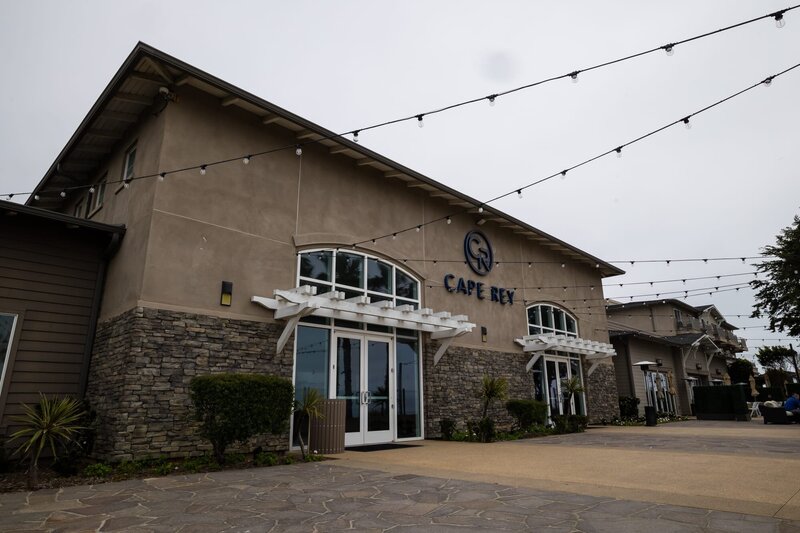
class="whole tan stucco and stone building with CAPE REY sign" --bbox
[0,44,622,459]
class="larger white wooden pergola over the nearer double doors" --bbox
[251,285,475,365]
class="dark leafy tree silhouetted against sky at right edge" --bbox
[750,215,800,337]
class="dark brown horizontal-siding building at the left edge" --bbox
[0,201,125,435]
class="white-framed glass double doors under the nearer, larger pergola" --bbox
[331,334,394,446]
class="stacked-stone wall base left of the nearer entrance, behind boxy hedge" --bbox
[87,307,293,461]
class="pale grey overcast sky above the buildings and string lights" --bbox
[0,0,800,366]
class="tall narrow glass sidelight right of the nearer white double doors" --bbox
[397,339,421,439]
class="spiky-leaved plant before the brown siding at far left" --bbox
[11,394,85,489]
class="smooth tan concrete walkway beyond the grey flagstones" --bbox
[340,421,800,521]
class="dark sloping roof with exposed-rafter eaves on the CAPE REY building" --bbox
[26,42,624,277]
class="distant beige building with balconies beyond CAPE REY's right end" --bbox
[607,300,747,415]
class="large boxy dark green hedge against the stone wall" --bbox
[189,374,294,464]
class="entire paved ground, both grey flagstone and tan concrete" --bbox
[0,422,800,533]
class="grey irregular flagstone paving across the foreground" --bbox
[0,461,800,533]
